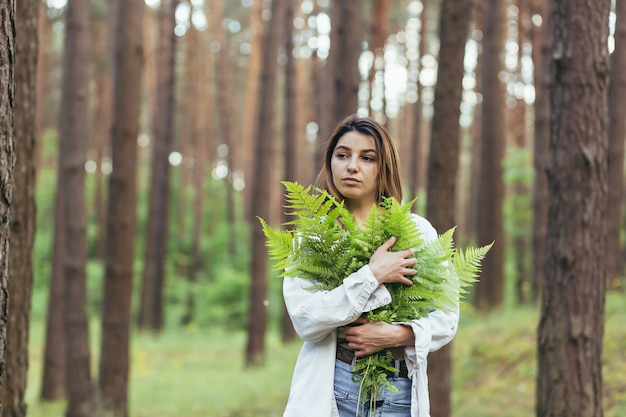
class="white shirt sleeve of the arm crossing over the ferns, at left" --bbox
[283,265,391,342]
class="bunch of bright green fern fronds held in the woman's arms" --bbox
[259,182,491,410]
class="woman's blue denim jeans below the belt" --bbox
[335,360,411,417]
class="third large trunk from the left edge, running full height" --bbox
[59,0,93,417]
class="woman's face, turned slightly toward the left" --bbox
[330,131,380,206]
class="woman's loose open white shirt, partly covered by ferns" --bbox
[283,214,459,417]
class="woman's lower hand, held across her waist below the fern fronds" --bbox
[337,317,415,359]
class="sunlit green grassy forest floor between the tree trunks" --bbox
[26,293,626,417]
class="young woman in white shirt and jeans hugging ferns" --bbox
[283,116,459,417]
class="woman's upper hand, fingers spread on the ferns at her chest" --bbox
[369,236,417,285]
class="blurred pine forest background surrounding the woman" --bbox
[0,0,626,417]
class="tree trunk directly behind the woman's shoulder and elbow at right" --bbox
[426,0,474,417]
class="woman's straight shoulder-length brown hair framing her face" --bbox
[317,115,402,204]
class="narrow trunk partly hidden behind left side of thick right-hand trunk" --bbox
[531,0,552,301]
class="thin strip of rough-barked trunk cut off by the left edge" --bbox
[0,0,16,413]
